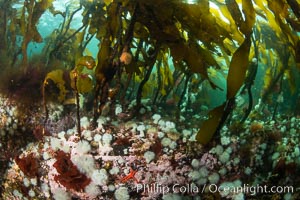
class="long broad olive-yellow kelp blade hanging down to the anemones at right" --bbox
[196,1,255,144]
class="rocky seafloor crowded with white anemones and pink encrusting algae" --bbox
[0,98,300,200]
